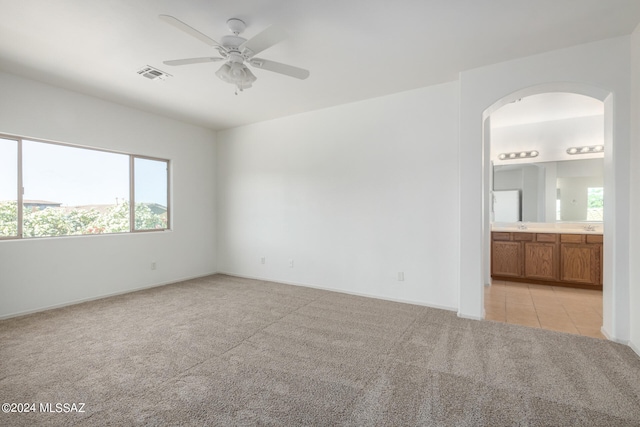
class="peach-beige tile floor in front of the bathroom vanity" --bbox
[484,280,605,339]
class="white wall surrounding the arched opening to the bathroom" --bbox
[460,37,631,341]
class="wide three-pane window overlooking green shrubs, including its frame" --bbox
[0,137,169,238]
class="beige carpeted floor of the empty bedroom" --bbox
[0,275,640,426]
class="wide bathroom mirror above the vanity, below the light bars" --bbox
[492,158,604,222]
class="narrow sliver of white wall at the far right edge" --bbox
[629,26,640,355]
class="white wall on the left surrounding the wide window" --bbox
[0,73,216,318]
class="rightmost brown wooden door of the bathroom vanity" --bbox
[560,243,600,285]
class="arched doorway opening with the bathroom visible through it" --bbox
[484,91,605,338]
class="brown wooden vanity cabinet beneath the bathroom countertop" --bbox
[491,232,602,289]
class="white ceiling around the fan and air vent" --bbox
[0,0,640,129]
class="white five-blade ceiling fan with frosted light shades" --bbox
[158,15,309,94]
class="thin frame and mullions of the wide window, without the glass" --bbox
[0,133,173,241]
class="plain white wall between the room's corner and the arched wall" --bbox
[217,83,459,309]
